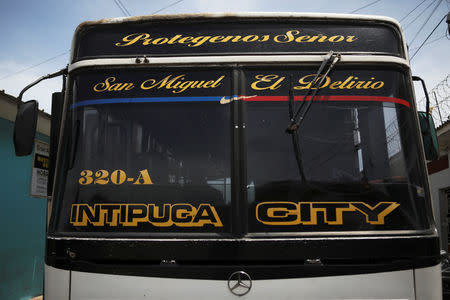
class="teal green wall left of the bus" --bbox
[0,118,49,300]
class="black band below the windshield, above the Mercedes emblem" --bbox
[46,236,439,280]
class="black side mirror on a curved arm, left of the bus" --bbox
[14,100,38,156]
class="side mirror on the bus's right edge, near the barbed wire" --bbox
[418,111,439,160]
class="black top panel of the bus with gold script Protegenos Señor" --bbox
[73,19,404,62]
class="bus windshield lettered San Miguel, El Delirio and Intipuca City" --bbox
[51,65,430,237]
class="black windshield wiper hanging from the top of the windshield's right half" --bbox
[286,51,341,182]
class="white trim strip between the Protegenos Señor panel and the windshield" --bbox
[69,54,409,72]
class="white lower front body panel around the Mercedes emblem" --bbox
[45,265,442,300]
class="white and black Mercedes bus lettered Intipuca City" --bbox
[15,13,442,300]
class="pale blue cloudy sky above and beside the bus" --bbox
[0,0,450,113]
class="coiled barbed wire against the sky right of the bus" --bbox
[417,74,450,127]
